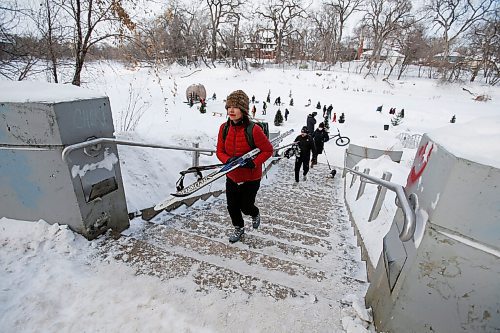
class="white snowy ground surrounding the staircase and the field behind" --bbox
[0,63,500,332]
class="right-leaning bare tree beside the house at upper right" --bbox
[363,0,413,69]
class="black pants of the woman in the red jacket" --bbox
[226,178,260,228]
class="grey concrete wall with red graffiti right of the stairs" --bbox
[366,135,500,332]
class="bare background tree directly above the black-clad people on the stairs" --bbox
[257,0,306,63]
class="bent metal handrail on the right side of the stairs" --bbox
[345,168,416,242]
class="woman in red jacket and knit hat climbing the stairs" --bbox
[217,90,273,243]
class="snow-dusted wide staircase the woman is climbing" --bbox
[102,160,367,332]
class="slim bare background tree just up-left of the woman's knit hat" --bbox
[205,0,243,62]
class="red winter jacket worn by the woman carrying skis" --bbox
[217,121,273,183]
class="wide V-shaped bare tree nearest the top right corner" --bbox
[424,0,498,61]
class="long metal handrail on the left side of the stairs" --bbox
[61,138,215,163]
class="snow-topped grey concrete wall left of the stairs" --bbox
[0,82,128,238]
